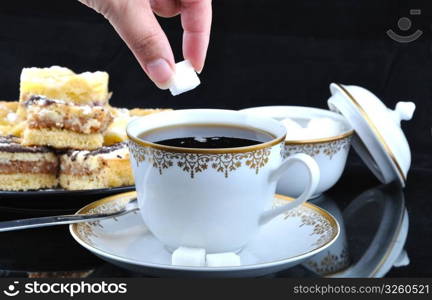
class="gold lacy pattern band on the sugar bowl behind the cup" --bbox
[283,135,352,159]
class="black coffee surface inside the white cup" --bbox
[139,124,274,149]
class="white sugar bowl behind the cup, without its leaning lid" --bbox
[242,106,354,198]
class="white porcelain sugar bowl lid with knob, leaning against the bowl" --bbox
[327,83,415,187]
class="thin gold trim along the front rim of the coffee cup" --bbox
[126,124,286,154]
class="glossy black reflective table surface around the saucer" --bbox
[0,165,432,277]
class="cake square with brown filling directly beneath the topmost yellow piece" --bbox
[22,96,112,149]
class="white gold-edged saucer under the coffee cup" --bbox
[70,192,339,277]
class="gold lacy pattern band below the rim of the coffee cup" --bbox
[129,140,271,178]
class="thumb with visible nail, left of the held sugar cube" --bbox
[80,0,175,89]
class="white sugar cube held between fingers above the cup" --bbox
[169,60,201,96]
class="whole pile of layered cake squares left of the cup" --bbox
[0,66,172,191]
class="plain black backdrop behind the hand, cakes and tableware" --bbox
[0,0,432,168]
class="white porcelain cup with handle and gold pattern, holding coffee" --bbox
[127,109,319,253]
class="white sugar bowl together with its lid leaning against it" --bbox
[243,83,416,197]
